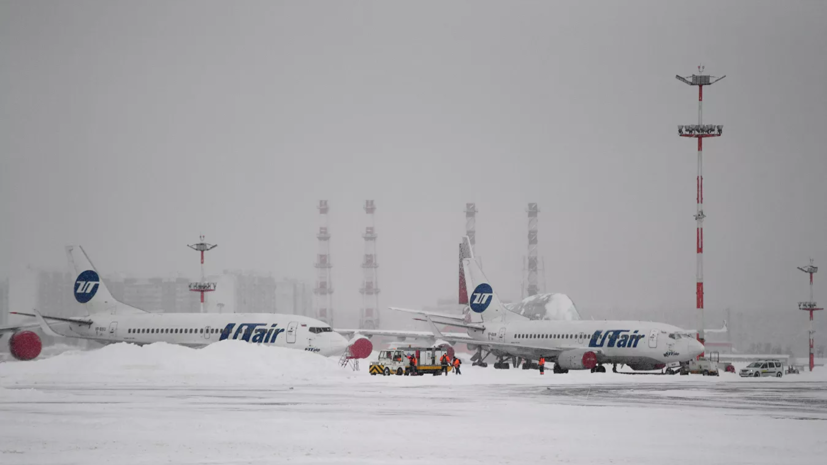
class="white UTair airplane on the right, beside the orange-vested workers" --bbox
[355,237,704,373]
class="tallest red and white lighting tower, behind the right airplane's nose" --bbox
[675,66,726,344]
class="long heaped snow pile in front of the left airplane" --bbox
[0,341,354,385]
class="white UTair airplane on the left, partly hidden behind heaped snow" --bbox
[0,246,373,360]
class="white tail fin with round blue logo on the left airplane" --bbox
[66,245,144,315]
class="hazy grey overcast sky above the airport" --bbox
[0,1,827,323]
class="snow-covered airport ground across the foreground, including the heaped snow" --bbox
[0,341,827,465]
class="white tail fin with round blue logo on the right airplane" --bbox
[460,236,528,323]
